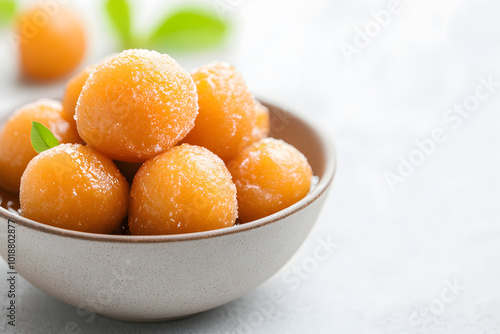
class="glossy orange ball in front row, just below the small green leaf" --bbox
[20,144,129,233]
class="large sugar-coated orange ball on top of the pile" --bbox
[76,50,198,162]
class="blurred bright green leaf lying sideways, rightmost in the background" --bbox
[149,8,229,51]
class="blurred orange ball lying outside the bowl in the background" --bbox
[16,6,86,80]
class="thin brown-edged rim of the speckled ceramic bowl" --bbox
[0,100,337,244]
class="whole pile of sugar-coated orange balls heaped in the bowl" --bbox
[0,50,312,235]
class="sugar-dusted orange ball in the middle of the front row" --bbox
[129,144,238,235]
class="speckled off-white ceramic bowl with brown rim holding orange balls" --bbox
[0,103,336,321]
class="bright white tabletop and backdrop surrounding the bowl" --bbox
[0,0,500,334]
